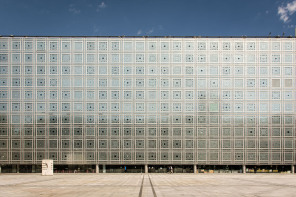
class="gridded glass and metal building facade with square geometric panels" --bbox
[0,36,296,172]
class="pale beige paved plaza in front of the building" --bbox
[0,174,296,197]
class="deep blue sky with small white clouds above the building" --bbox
[0,0,296,36]
